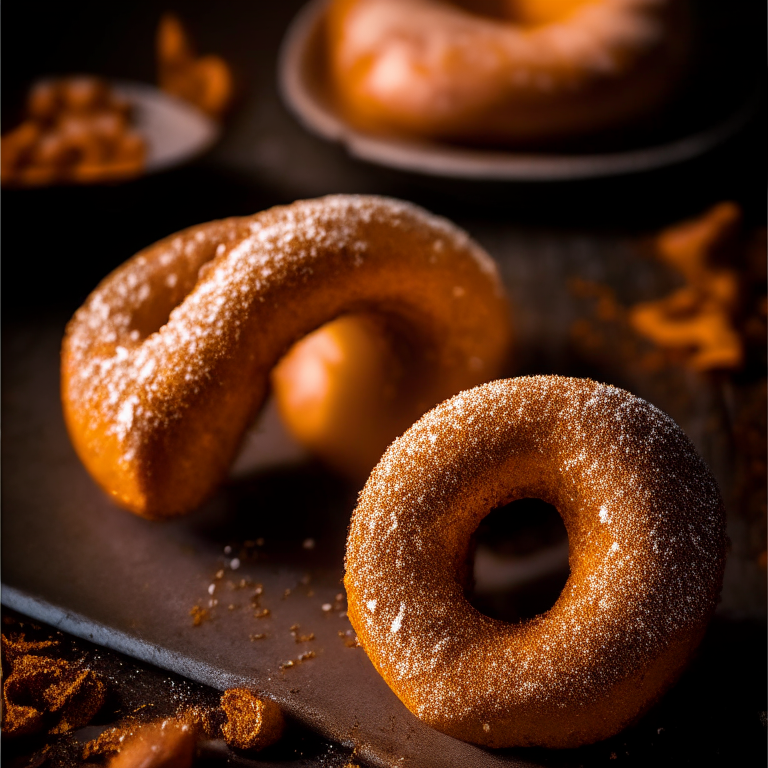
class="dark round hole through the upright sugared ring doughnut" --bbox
[468,499,570,622]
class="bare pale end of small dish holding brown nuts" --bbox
[113,82,221,173]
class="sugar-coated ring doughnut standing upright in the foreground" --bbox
[344,376,726,747]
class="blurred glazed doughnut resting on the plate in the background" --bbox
[327,0,690,143]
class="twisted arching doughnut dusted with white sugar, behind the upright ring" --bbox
[62,195,509,517]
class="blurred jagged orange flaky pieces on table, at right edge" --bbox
[568,202,765,372]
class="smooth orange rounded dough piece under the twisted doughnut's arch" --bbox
[272,315,434,481]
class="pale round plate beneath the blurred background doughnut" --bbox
[279,0,758,182]
